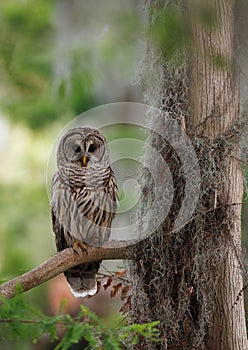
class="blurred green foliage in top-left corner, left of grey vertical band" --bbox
[0,0,58,128]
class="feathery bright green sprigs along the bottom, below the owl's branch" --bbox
[0,295,159,350]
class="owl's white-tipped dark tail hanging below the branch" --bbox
[65,262,100,298]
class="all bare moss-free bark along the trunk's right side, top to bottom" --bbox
[188,0,248,350]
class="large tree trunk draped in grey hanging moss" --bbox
[131,0,248,350]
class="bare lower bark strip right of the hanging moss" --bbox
[208,159,245,350]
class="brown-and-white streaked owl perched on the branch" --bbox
[51,128,118,297]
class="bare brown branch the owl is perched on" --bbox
[0,241,135,298]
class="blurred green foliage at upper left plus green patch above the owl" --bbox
[0,0,95,129]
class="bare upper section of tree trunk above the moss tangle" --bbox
[189,0,239,138]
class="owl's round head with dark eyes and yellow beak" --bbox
[57,128,109,171]
